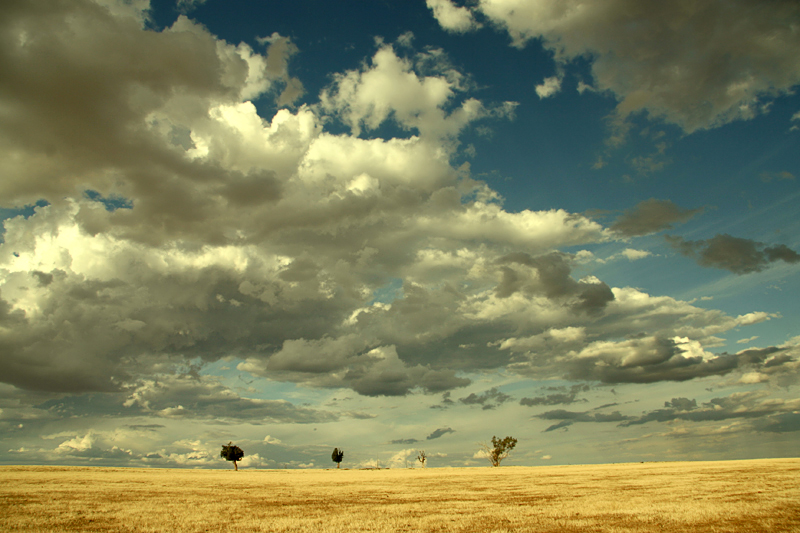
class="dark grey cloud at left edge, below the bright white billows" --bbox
[0,262,362,393]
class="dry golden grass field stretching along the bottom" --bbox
[0,459,800,533]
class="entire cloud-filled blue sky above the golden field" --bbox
[0,0,800,468]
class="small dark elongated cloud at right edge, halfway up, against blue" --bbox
[666,233,800,275]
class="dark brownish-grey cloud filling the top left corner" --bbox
[0,0,300,212]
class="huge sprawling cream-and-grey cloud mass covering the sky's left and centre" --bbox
[0,0,792,412]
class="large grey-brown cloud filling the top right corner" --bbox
[466,0,800,133]
